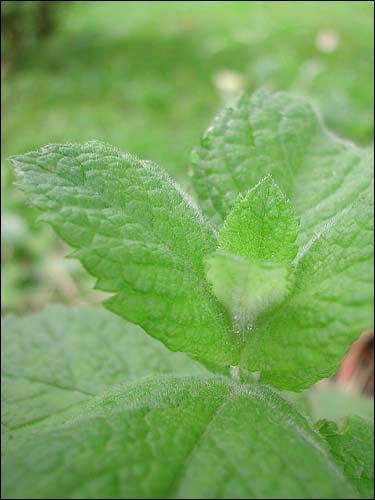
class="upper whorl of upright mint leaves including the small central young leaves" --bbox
[14,92,372,390]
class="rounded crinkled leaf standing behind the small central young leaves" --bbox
[192,90,373,245]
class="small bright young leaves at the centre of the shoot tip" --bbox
[207,176,298,332]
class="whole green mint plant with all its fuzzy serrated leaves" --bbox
[3,91,373,498]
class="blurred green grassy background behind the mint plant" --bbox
[1,1,374,313]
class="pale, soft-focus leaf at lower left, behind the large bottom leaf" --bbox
[1,306,206,434]
